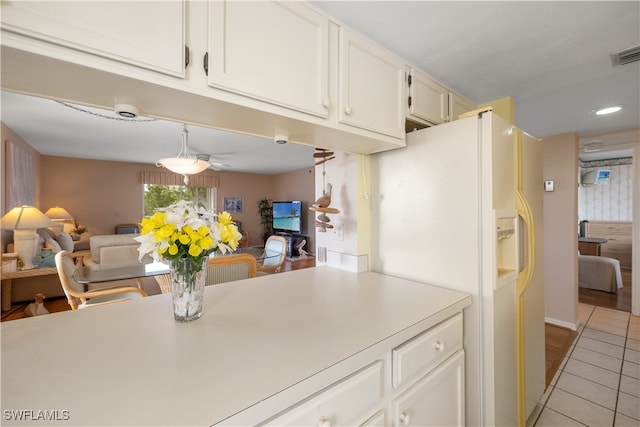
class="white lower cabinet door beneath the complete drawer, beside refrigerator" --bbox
[392,350,464,426]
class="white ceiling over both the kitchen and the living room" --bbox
[1,1,640,174]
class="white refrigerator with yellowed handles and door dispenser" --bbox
[371,110,545,426]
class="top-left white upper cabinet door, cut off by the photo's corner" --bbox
[2,1,185,77]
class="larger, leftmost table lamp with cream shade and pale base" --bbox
[0,205,55,270]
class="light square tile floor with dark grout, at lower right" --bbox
[533,304,640,427]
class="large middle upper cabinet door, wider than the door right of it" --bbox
[208,1,329,117]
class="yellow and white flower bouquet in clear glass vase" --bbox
[136,200,242,322]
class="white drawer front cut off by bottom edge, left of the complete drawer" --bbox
[266,361,383,426]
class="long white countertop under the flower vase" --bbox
[1,266,471,426]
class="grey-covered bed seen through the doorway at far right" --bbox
[578,255,622,293]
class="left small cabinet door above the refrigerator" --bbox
[407,68,449,124]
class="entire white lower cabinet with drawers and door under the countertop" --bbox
[261,313,465,427]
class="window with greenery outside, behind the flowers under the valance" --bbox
[144,184,216,216]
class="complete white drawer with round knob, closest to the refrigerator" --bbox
[392,313,462,388]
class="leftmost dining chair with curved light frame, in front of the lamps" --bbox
[55,251,147,310]
